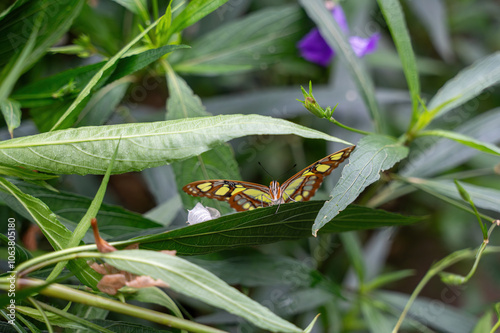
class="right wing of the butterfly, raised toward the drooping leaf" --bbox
[281,146,356,202]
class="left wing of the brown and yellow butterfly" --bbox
[182,179,272,212]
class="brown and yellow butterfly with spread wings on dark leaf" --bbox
[182,146,356,212]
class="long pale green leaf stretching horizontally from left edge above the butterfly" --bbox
[0,115,349,175]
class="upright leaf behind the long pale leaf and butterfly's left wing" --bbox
[166,70,241,213]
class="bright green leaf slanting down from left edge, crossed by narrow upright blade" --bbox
[0,177,100,289]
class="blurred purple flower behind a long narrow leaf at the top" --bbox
[297,5,380,67]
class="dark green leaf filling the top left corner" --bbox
[0,0,85,71]
